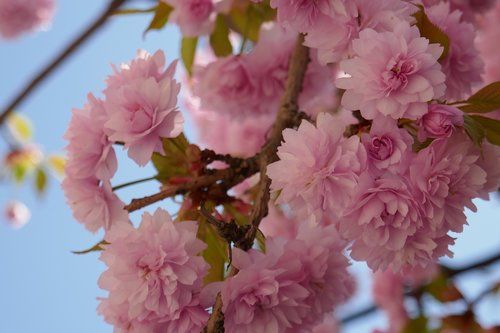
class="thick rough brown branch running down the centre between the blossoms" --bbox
[203,35,309,333]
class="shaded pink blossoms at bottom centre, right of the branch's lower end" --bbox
[221,224,353,333]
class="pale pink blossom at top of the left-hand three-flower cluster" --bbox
[105,51,184,165]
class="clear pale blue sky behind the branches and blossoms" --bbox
[0,0,500,333]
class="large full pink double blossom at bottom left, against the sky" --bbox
[98,208,208,333]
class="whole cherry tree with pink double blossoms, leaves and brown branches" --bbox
[0,0,500,333]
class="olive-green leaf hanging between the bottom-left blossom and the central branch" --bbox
[197,218,229,284]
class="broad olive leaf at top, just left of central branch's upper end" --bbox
[228,2,276,43]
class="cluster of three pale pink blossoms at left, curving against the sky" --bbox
[62,51,183,232]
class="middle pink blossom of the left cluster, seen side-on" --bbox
[64,94,118,180]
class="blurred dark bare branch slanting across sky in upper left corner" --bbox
[0,0,127,125]
